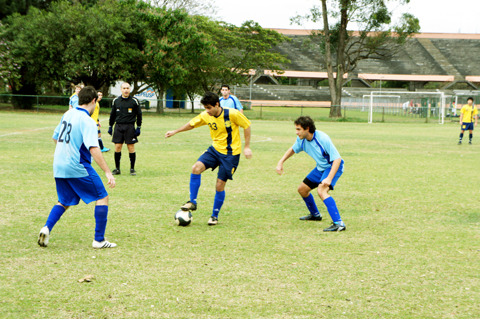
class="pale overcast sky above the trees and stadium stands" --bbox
[215,0,480,33]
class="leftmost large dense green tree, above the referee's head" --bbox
[2,0,145,103]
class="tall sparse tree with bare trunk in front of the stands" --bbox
[292,0,420,117]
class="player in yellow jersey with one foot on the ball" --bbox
[165,92,252,226]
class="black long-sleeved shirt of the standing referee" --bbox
[109,96,142,126]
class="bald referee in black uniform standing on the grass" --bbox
[108,82,142,176]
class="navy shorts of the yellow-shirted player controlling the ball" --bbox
[198,146,240,182]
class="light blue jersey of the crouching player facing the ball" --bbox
[292,131,341,172]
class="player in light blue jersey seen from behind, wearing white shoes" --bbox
[38,86,116,248]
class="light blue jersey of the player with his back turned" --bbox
[52,107,98,178]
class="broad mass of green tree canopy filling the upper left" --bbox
[0,0,287,109]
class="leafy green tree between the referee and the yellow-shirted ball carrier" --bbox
[139,5,215,112]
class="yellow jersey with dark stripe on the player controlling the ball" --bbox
[190,108,251,155]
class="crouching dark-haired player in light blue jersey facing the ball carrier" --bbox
[276,116,347,231]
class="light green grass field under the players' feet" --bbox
[0,112,480,318]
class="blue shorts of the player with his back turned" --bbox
[55,167,108,206]
